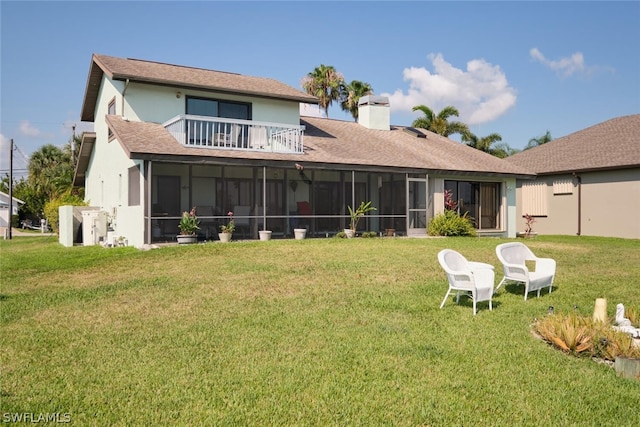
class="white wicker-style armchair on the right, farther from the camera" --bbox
[496,242,556,301]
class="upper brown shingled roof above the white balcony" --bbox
[81,54,318,122]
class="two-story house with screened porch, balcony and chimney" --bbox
[74,55,535,246]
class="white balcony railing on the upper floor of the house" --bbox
[163,114,304,153]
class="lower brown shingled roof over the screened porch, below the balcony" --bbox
[96,116,533,177]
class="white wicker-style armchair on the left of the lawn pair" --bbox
[438,249,495,316]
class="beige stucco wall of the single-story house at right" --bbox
[517,168,640,239]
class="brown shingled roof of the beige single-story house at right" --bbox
[506,114,640,174]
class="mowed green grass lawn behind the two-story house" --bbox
[0,236,640,426]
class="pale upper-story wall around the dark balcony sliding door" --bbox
[122,82,300,125]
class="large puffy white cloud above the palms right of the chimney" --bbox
[382,54,516,125]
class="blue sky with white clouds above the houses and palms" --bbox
[0,0,640,175]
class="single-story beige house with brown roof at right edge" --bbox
[507,114,640,239]
